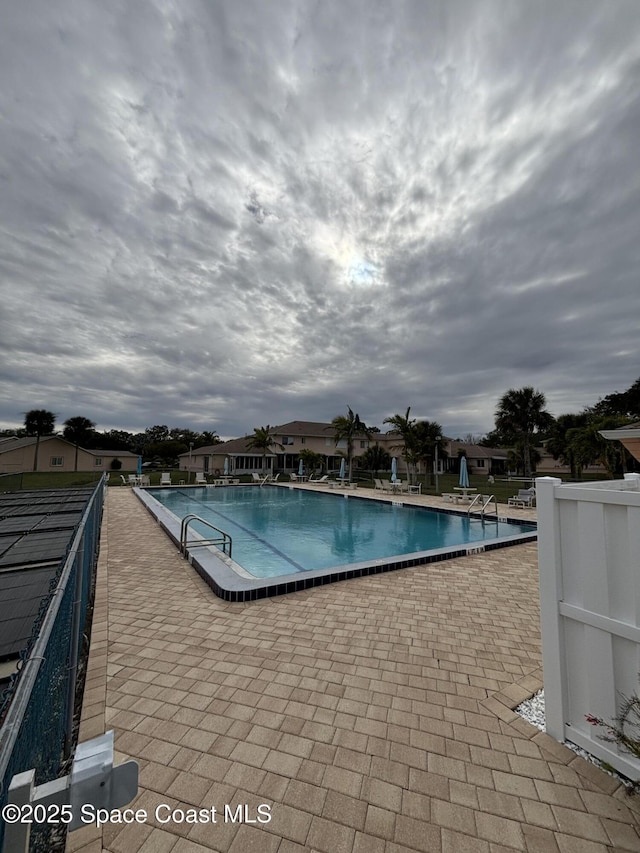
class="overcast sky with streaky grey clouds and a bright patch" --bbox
[0,0,640,437]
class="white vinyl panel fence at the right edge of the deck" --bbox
[536,474,640,780]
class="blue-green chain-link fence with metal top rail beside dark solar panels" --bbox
[0,482,105,851]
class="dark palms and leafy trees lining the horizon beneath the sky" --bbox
[6,378,640,479]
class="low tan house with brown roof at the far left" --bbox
[0,435,138,474]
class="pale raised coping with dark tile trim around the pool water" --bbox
[133,483,538,602]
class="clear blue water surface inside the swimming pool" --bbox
[148,486,535,578]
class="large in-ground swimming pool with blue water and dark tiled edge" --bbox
[138,486,536,600]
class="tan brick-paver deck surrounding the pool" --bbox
[67,486,640,853]
